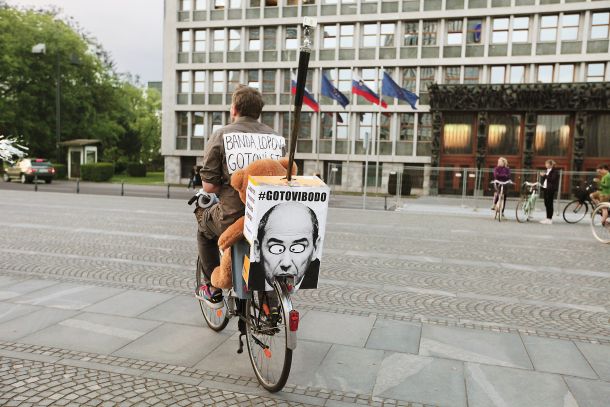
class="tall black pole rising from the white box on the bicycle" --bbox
[286,20,315,181]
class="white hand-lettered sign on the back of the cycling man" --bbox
[223,133,286,174]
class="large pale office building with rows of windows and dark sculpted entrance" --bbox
[162,0,610,191]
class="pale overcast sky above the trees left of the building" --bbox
[7,0,163,84]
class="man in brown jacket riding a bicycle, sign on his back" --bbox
[195,85,285,310]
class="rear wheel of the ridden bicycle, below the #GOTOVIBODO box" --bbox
[246,282,292,393]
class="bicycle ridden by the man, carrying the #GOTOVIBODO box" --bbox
[189,190,299,393]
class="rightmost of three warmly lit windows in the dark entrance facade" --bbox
[534,114,570,156]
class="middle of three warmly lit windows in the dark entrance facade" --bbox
[487,114,521,155]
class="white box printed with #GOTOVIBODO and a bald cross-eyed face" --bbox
[243,176,330,290]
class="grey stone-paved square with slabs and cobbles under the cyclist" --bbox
[0,190,610,407]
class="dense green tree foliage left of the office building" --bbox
[0,1,161,163]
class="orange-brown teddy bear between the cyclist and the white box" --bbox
[212,157,297,289]
